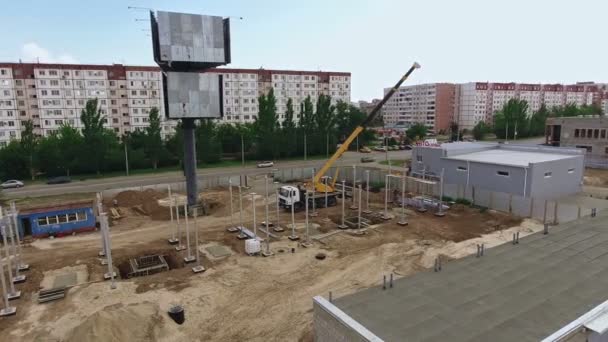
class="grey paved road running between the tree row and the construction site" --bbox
[3,151,411,198]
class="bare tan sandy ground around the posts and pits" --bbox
[0,184,542,341]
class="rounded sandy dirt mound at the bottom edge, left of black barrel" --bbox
[65,302,165,342]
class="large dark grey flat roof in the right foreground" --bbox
[334,212,608,341]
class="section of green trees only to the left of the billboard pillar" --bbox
[0,99,169,179]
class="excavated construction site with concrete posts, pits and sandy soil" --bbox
[0,165,542,341]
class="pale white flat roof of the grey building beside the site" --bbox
[445,148,578,166]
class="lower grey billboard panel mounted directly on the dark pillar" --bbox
[163,71,223,119]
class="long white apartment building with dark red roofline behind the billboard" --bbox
[0,63,350,146]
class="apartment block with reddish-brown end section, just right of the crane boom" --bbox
[383,83,456,132]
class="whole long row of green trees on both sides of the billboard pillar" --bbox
[0,90,374,179]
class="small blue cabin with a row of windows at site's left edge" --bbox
[17,200,96,238]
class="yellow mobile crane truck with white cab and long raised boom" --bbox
[279,63,420,209]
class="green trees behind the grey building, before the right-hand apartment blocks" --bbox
[472,99,602,140]
